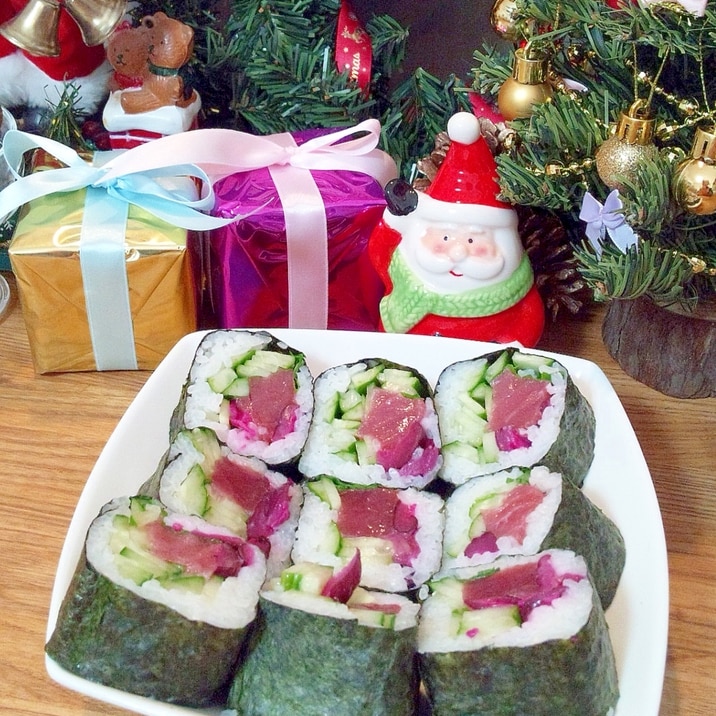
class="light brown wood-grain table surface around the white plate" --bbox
[0,274,716,716]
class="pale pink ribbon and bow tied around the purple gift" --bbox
[106,119,397,329]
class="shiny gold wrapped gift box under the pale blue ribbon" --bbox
[9,189,197,373]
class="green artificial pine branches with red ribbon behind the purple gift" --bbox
[122,0,470,177]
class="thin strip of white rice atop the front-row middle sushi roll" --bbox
[261,585,420,631]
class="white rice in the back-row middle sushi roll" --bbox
[298,363,442,488]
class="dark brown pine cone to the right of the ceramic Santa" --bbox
[516,206,592,320]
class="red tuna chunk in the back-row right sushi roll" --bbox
[488,370,550,433]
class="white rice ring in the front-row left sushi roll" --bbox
[86,497,266,629]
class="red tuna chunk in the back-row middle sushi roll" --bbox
[357,388,425,470]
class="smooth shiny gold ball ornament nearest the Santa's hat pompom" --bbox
[497,47,554,121]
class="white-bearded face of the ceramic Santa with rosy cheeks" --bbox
[401,224,515,293]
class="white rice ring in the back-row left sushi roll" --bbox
[183,330,313,465]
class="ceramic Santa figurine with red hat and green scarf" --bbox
[369,112,545,347]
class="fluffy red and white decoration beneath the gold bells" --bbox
[0,0,112,114]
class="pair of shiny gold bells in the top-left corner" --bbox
[0,0,126,57]
